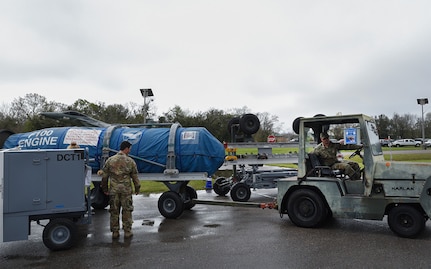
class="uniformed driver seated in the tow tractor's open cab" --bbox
[313,133,362,180]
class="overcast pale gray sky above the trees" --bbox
[0,0,431,131]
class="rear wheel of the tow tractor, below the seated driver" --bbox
[287,189,328,228]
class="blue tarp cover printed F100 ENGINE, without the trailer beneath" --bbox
[3,127,225,175]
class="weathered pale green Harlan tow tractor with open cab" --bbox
[277,114,431,238]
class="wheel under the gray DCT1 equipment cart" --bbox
[42,218,77,251]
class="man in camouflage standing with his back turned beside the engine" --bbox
[100,141,141,238]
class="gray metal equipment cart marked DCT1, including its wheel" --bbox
[0,149,87,249]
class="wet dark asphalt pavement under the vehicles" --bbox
[0,186,431,269]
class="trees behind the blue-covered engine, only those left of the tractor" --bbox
[0,93,280,141]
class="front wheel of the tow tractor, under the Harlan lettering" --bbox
[388,205,426,238]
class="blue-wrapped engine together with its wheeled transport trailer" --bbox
[0,123,225,222]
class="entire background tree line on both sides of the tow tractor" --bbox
[0,93,431,142]
